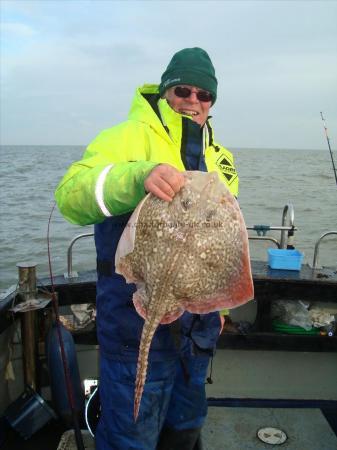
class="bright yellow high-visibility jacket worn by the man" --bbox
[55,85,239,225]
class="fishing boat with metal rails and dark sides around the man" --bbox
[0,204,337,450]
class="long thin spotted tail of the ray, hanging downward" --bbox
[133,319,160,422]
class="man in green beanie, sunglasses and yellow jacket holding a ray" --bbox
[56,48,238,450]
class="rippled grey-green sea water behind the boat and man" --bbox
[0,145,337,290]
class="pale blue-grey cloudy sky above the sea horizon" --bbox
[0,0,337,149]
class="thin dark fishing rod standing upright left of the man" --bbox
[47,202,85,450]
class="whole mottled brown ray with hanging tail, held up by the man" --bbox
[116,172,254,420]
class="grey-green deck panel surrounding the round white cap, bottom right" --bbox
[203,407,337,450]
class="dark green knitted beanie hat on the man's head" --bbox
[159,47,218,104]
